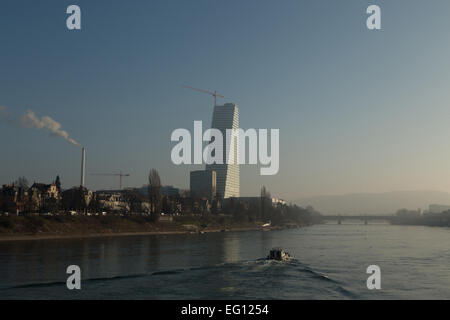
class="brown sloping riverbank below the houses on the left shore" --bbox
[0,216,305,242]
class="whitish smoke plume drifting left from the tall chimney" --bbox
[0,106,81,147]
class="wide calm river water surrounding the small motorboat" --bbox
[0,223,450,299]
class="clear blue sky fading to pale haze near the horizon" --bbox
[0,0,450,200]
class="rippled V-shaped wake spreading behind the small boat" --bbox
[0,258,354,299]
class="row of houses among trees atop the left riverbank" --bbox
[0,182,220,215]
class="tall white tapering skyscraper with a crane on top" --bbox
[206,103,240,198]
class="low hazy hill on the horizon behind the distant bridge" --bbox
[294,191,450,215]
